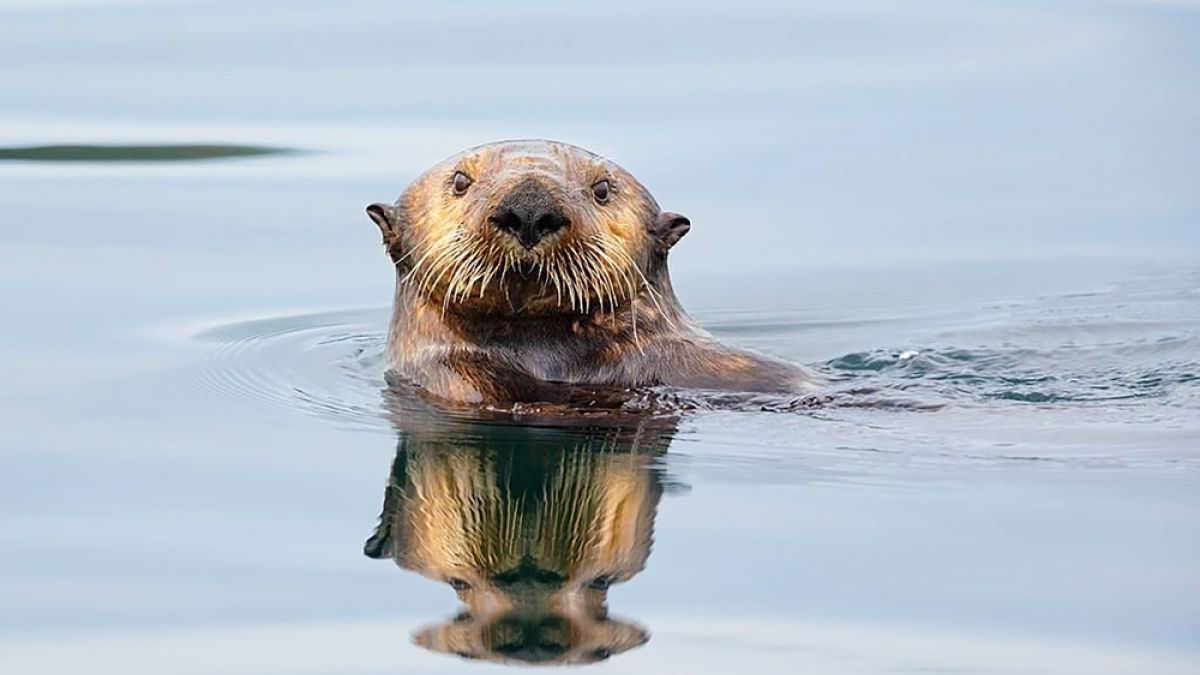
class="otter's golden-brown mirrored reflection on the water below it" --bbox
[365,419,674,664]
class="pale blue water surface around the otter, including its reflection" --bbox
[0,0,1200,675]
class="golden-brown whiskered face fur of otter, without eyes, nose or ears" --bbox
[396,142,658,315]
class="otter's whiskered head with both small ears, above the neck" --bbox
[367,141,690,315]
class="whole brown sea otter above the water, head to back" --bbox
[367,141,816,405]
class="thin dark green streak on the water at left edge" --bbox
[0,144,296,162]
